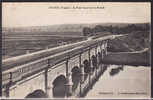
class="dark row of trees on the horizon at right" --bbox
[83,23,150,36]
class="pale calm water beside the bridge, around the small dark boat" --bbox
[86,65,151,99]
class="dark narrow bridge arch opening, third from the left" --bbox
[71,66,81,91]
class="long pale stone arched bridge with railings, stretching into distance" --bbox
[2,35,149,98]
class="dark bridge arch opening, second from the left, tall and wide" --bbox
[52,75,67,98]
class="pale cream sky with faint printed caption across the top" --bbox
[2,2,151,27]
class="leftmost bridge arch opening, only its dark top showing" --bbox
[25,89,47,98]
